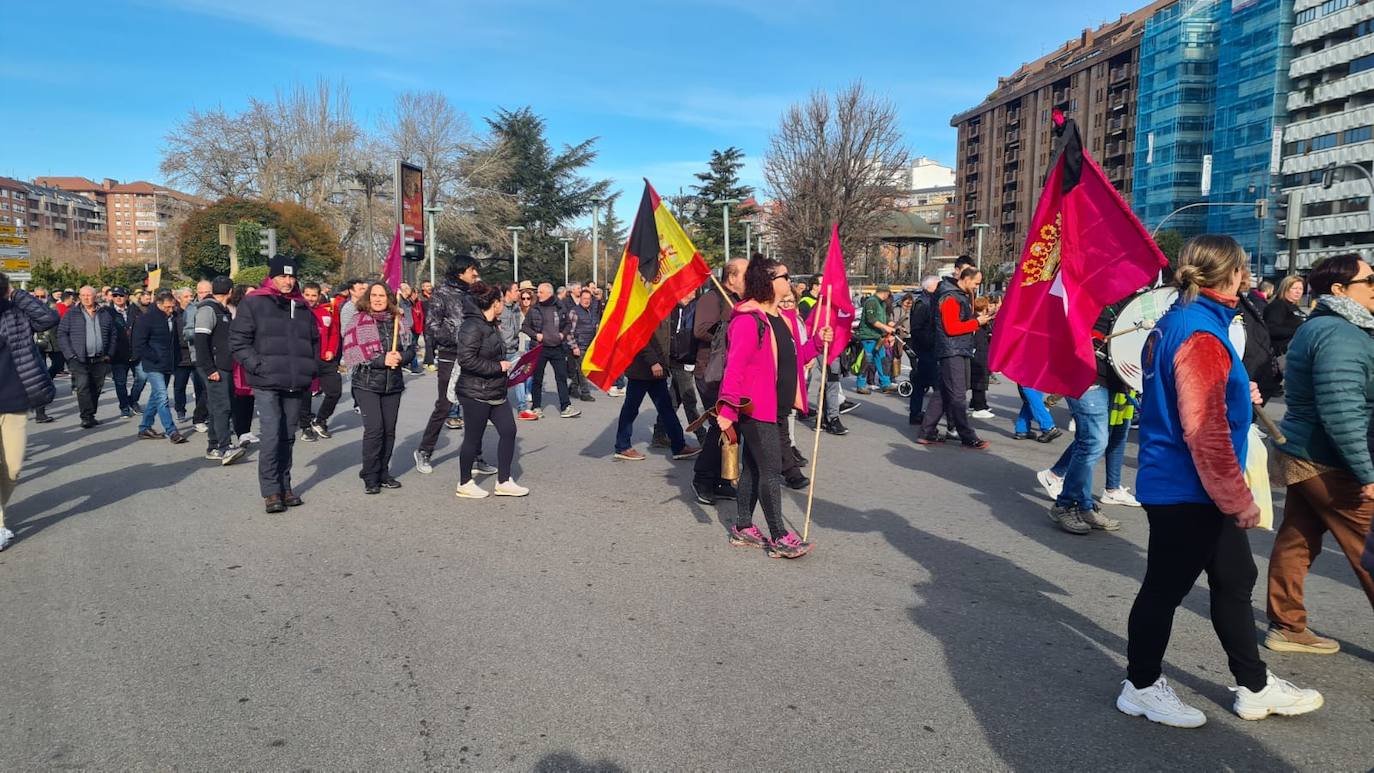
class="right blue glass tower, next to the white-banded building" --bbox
[1206,0,1293,276]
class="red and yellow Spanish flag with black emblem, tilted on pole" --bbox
[583,180,710,391]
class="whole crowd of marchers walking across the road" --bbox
[0,236,1374,726]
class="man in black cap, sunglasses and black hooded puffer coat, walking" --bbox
[229,255,320,514]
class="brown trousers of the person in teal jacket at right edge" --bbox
[1268,471,1374,632]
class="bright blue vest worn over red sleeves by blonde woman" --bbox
[1135,295,1252,505]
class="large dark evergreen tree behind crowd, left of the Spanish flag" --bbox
[486,107,610,281]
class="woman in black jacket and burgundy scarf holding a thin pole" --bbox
[344,283,415,494]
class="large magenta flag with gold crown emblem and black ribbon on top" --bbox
[989,110,1169,398]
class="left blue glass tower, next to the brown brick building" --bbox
[1132,0,1221,236]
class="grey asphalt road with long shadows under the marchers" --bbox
[0,376,1374,772]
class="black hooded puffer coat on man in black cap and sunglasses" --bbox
[229,288,320,391]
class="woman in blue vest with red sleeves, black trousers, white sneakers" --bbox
[1117,235,1322,728]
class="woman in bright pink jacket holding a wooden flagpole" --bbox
[717,255,831,559]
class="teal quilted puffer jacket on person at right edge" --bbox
[1281,310,1374,485]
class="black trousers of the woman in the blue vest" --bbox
[1125,503,1267,691]
